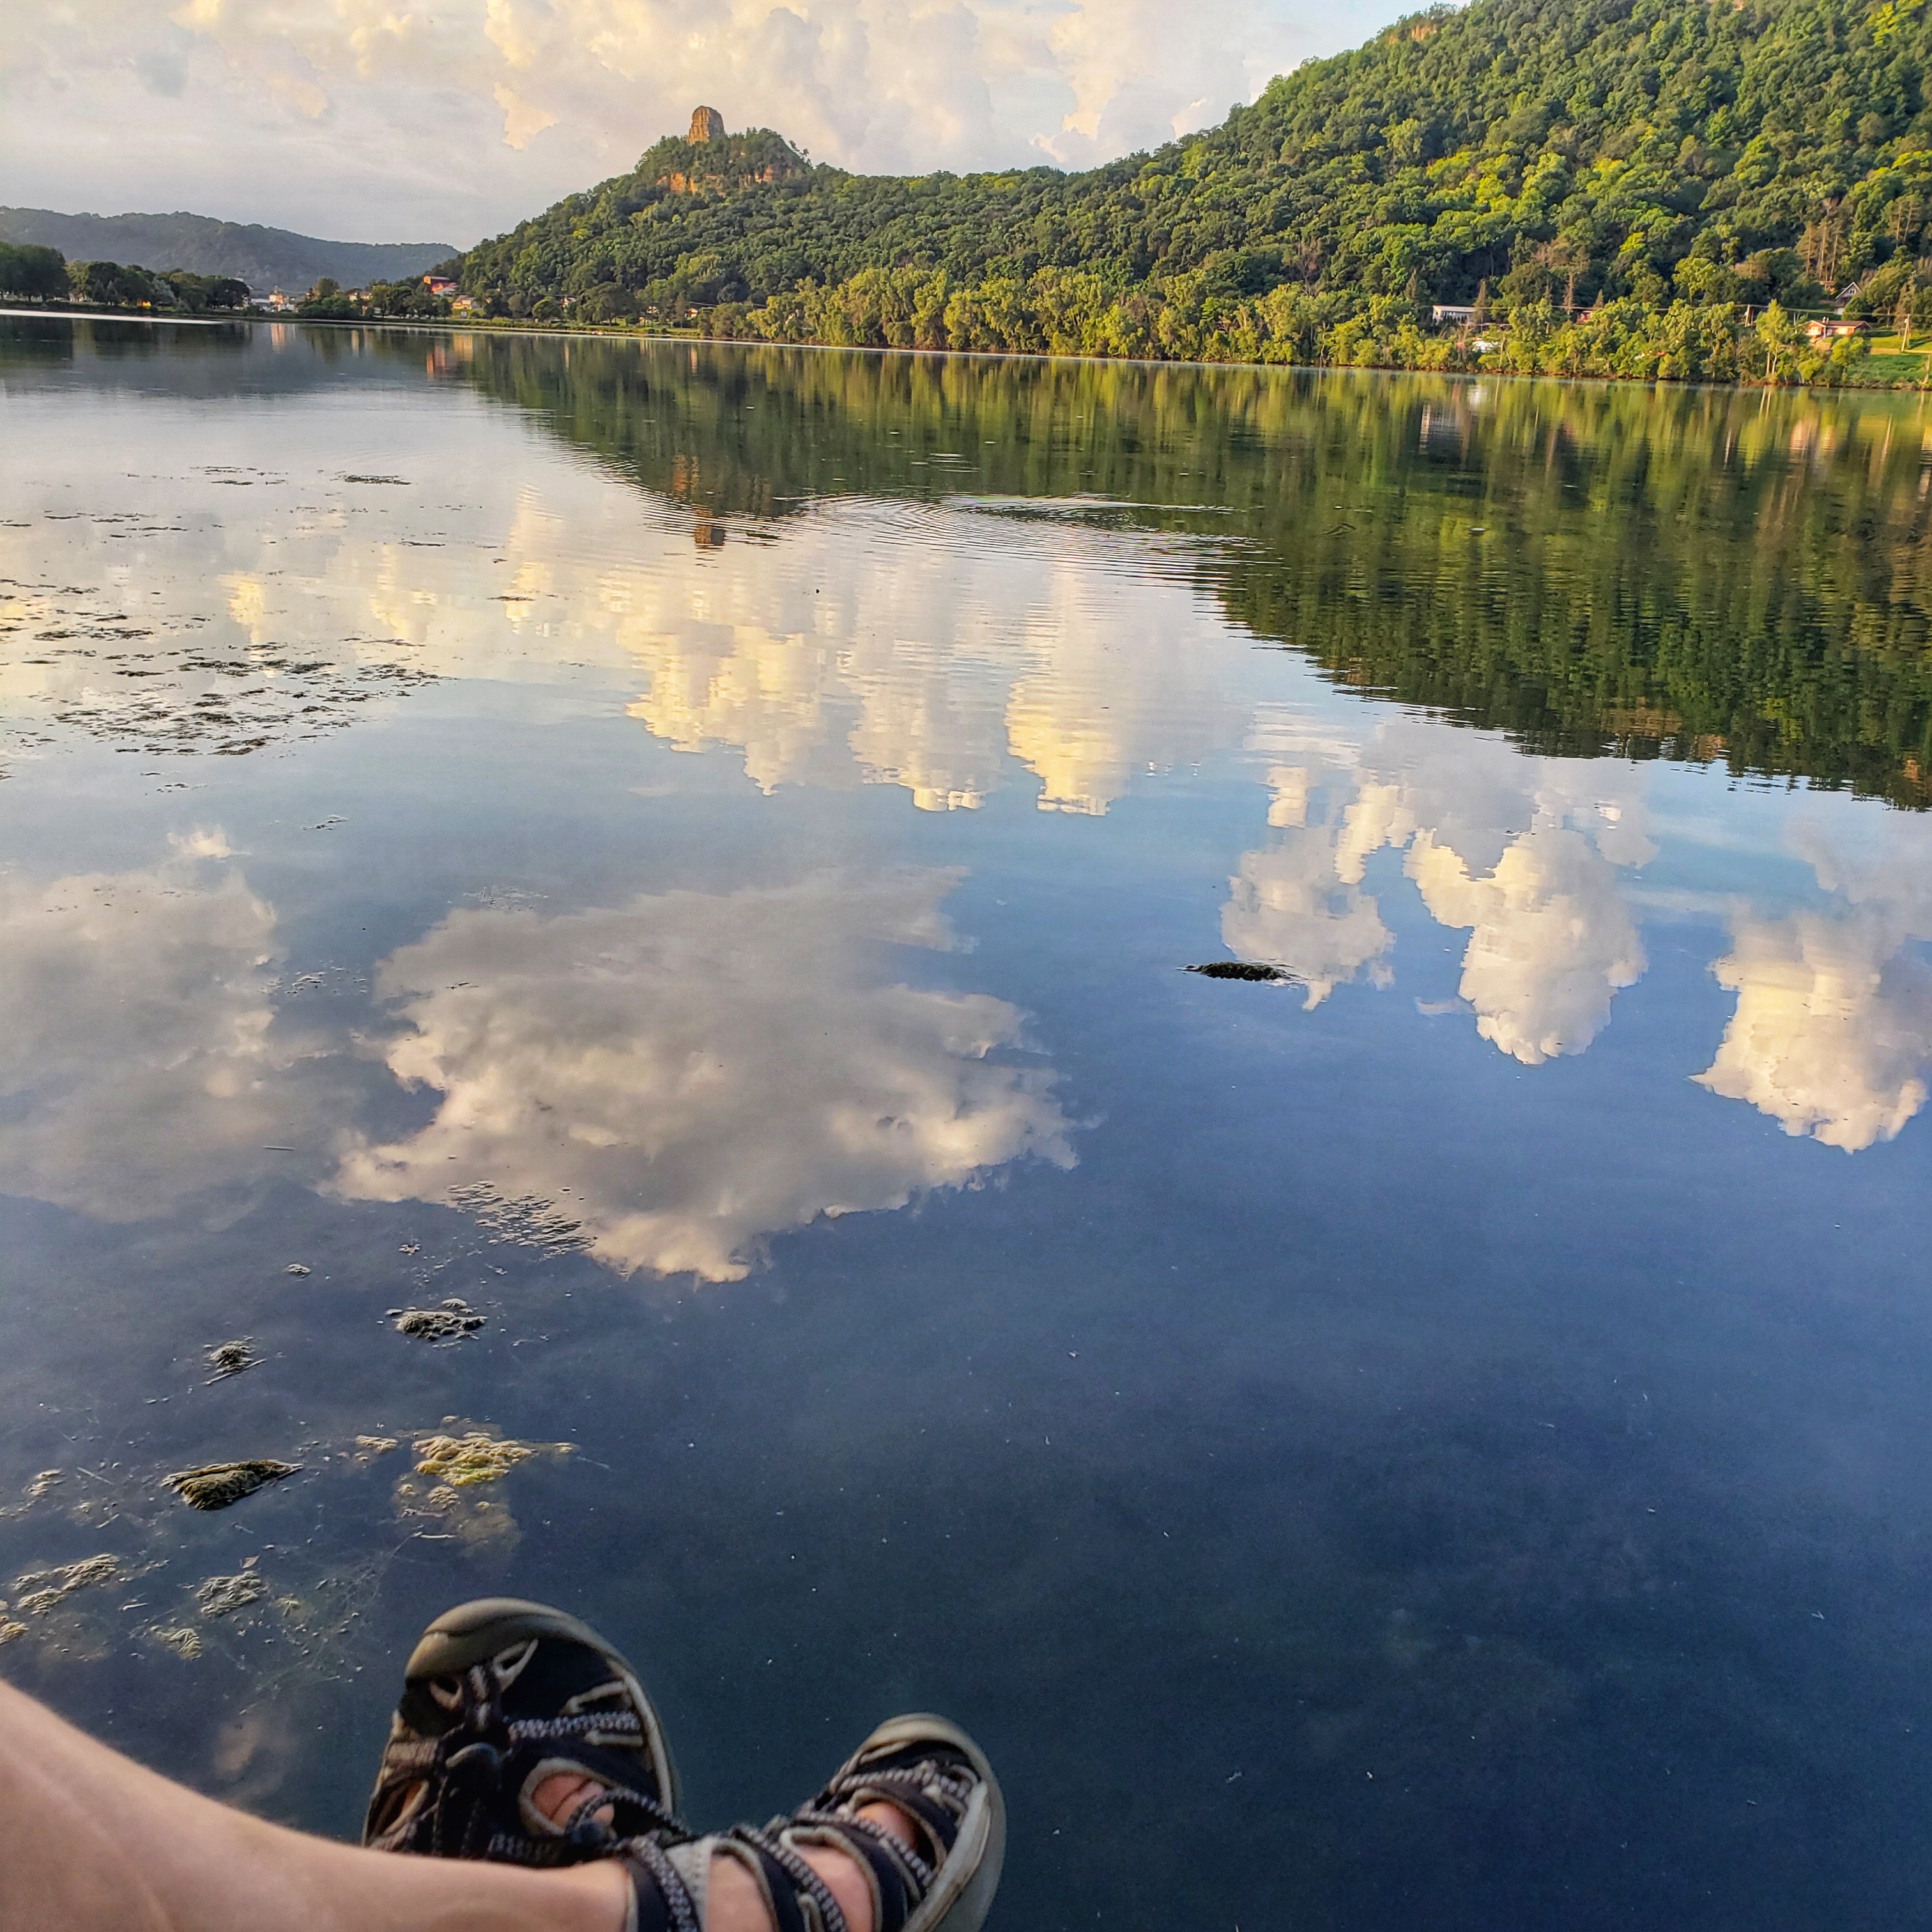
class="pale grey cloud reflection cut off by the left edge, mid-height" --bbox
[0,854,336,1221]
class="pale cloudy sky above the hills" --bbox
[0,0,1404,247]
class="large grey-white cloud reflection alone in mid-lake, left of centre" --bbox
[336,873,1072,1281]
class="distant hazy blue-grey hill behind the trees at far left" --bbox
[0,209,456,294]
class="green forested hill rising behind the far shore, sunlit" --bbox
[462,0,1932,375]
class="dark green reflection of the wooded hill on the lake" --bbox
[442,334,1932,808]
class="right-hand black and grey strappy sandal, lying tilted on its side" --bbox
[617,1715,1007,1932]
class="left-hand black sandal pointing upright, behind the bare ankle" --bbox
[364,1596,690,1864]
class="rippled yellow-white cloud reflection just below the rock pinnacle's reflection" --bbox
[599,504,1240,817]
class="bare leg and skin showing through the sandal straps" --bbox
[0,1683,914,1932]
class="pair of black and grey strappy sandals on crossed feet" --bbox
[364,1598,1007,1932]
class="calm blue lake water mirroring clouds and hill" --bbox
[0,319,1932,1932]
